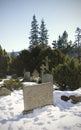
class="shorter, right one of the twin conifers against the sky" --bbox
[39,19,48,47]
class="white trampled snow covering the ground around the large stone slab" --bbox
[0,82,81,130]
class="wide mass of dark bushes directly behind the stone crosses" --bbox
[10,45,66,76]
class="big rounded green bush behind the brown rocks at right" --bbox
[53,59,81,90]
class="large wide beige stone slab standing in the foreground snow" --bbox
[23,83,53,112]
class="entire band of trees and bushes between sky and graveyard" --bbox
[0,15,81,89]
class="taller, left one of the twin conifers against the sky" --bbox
[29,15,39,49]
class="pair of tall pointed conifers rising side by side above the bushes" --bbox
[29,15,48,50]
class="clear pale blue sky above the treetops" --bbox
[0,0,81,52]
